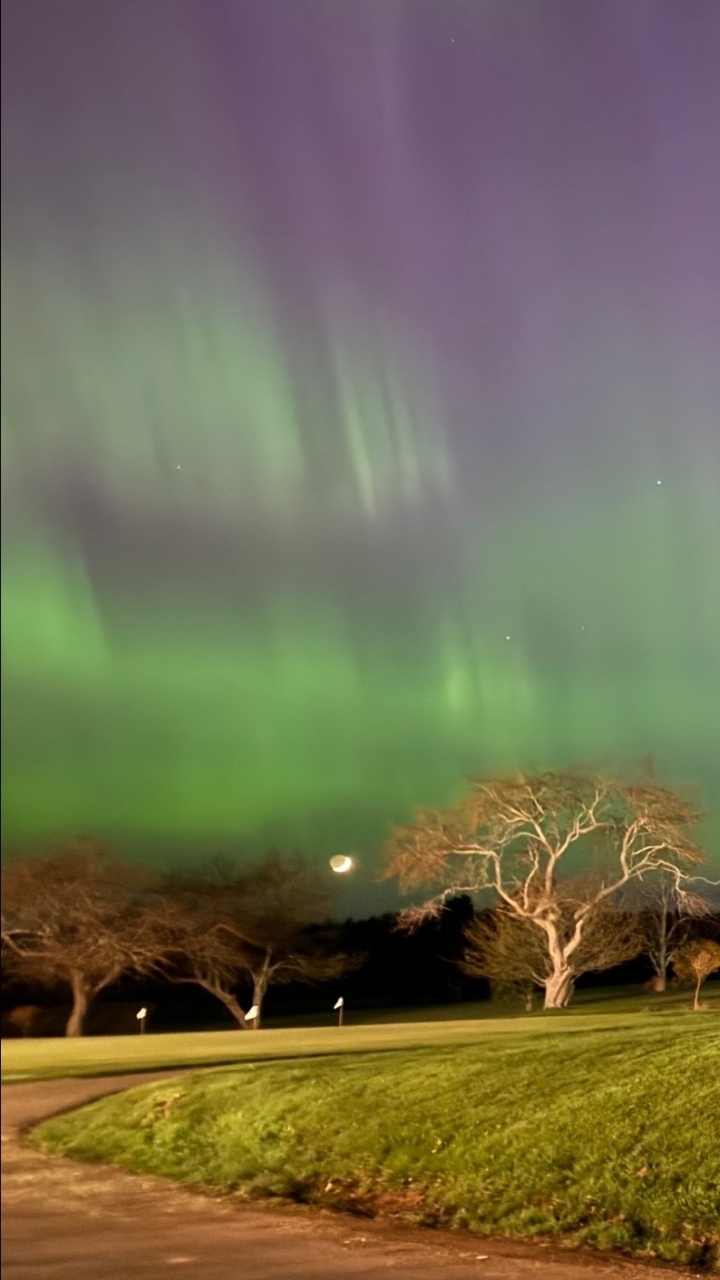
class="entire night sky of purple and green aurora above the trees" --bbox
[3,0,720,901]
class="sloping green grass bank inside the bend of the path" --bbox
[32,1015,720,1270]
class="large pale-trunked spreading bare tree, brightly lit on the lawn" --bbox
[386,769,703,1009]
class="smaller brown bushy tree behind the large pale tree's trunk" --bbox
[460,879,643,1011]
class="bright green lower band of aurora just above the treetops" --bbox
[3,519,715,870]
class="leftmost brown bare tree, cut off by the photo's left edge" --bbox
[3,840,154,1036]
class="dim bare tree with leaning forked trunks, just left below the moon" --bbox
[149,852,360,1029]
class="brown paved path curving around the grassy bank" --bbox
[3,1073,691,1280]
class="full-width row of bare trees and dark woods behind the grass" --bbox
[1,803,720,1036]
